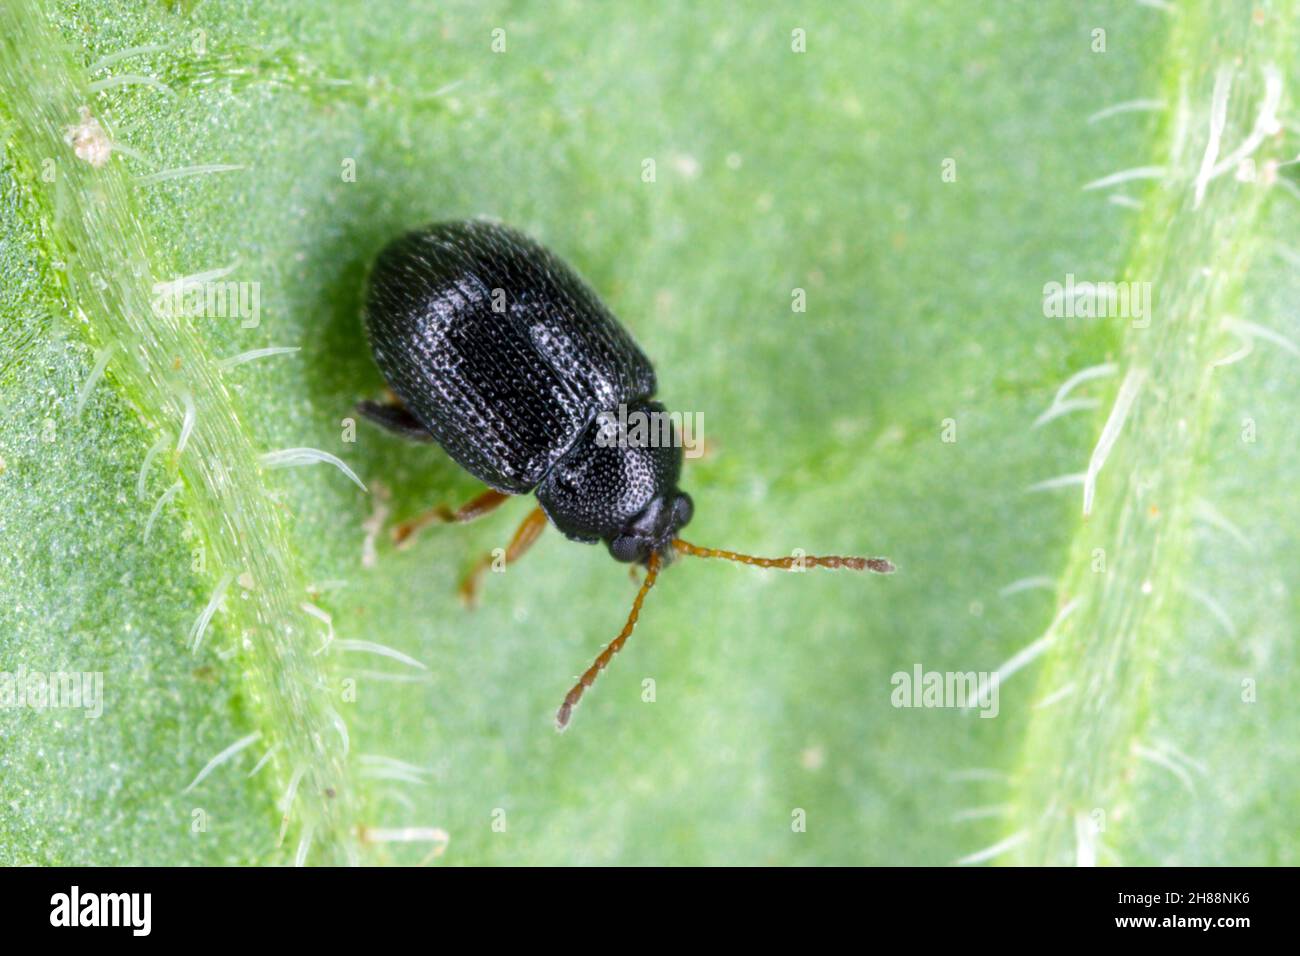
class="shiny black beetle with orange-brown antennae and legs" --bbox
[358,221,894,730]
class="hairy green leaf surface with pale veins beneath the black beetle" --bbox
[0,0,1300,865]
